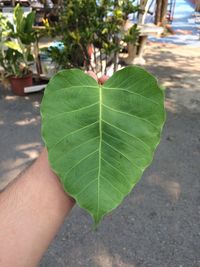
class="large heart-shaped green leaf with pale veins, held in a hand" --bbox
[41,66,165,224]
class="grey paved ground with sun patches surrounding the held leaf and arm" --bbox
[0,44,200,267]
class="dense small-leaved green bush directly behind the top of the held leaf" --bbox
[46,0,139,72]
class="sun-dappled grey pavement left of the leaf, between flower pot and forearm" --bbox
[0,88,42,189]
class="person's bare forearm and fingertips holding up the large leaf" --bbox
[0,73,108,267]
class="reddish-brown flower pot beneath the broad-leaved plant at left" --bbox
[9,74,33,96]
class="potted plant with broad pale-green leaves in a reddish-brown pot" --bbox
[0,5,36,95]
